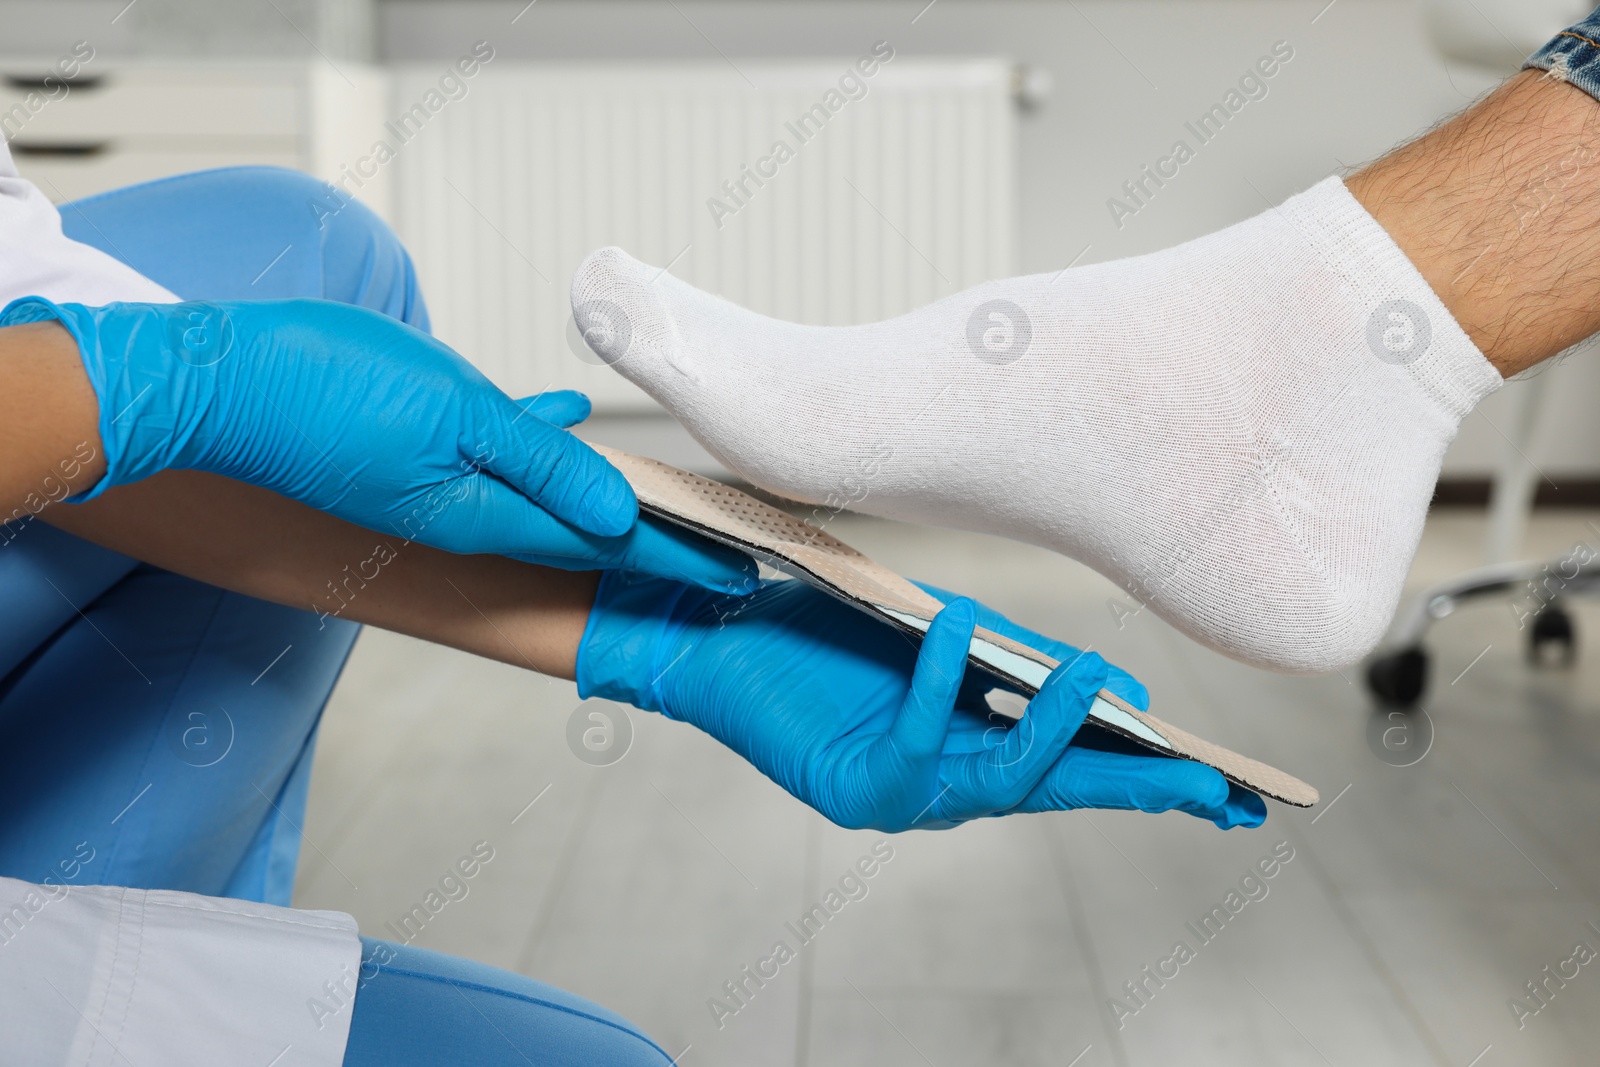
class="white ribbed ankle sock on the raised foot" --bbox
[573,178,1501,670]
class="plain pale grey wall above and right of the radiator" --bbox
[379,0,1600,480]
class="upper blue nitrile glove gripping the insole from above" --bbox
[0,298,755,589]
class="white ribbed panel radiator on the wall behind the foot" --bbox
[387,59,1016,411]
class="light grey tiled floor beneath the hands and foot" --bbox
[296,512,1600,1067]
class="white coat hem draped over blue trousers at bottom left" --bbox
[0,878,362,1067]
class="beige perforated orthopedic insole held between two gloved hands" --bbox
[594,445,1317,808]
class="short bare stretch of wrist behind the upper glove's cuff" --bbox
[0,323,106,511]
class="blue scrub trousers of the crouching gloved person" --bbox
[0,166,670,1067]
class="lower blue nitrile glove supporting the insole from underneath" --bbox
[578,571,1264,830]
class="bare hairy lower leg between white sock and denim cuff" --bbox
[1346,70,1600,376]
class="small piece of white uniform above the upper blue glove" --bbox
[0,139,178,307]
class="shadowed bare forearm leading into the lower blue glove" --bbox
[42,470,598,678]
